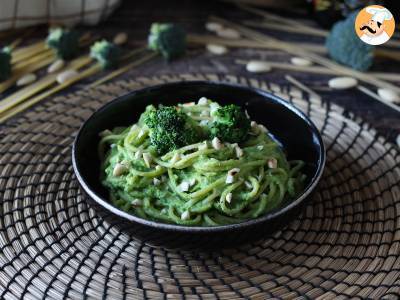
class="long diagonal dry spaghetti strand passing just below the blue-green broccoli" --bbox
[211,17,400,93]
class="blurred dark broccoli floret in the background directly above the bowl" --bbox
[148,23,186,60]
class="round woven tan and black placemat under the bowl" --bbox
[0,75,400,300]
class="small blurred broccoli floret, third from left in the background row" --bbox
[90,40,121,69]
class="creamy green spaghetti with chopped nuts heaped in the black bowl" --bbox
[99,98,305,226]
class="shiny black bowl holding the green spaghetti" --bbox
[72,82,325,248]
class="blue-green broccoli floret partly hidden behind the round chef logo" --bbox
[325,11,374,71]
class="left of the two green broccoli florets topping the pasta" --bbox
[145,106,202,154]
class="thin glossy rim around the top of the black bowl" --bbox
[72,80,326,233]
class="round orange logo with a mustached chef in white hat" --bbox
[354,5,395,45]
